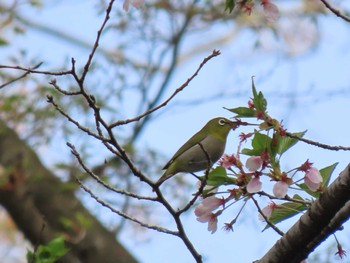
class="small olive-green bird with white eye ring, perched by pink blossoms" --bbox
[156,117,235,186]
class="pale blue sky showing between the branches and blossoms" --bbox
[4,1,350,263]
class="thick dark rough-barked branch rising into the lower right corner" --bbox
[256,164,350,263]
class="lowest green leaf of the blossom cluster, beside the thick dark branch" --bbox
[264,195,307,230]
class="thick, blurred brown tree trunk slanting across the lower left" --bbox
[0,121,137,263]
